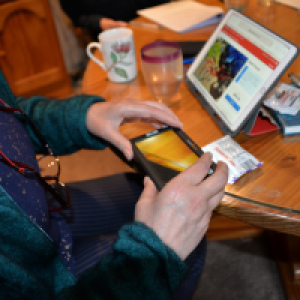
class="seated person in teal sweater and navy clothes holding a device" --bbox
[0,72,228,300]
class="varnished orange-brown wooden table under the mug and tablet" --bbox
[83,0,300,299]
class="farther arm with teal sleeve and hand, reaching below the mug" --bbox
[17,95,182,160]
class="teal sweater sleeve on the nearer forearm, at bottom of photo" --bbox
[57,222,186,300]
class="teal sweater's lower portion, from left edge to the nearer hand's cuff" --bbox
[0,185,186,300]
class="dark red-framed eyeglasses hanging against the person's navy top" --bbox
[0,98,70,212]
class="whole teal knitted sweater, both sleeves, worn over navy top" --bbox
[0,72,186,300]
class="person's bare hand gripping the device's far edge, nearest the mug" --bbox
[86,99,182,160]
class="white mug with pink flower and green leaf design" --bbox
[86,28,137,82]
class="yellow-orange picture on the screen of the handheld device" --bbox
[136,130,198,172]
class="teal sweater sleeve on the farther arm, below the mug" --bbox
[16,95,105,155]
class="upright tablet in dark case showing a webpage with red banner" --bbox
[185,10,299,137]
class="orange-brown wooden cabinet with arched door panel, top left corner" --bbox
[0,0,72,97]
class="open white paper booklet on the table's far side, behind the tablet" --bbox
[138,0,223,32]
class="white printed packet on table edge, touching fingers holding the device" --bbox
[202,135,263,184]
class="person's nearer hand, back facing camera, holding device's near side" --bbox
[135,153,228,260]
